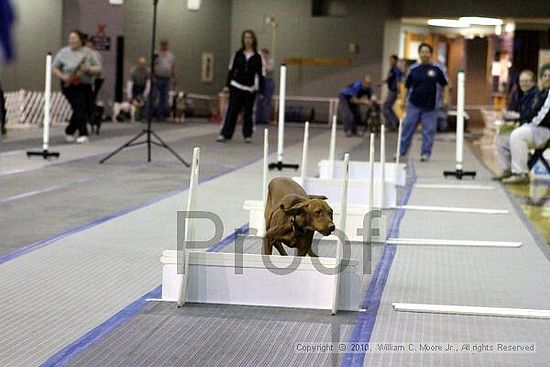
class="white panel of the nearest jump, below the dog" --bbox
[161,250,361,311]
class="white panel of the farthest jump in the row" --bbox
[319,159,407,186]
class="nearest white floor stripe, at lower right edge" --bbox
[392,303,550,319]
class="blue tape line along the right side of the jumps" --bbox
[340,159,417,367]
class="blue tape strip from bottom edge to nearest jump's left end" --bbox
[40,286,161,367]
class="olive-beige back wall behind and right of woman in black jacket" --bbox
[231,0,392,96]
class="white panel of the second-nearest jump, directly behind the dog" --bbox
[243,200,387,242]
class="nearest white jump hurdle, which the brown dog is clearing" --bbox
[160,147,362,314]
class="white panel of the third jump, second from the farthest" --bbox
[292,177,397,208]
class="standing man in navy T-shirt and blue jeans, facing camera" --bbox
[400,43,449,162]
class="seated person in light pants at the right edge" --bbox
[498,64,550,184]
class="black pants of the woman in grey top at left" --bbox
[63,84,92,136]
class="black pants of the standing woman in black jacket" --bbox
[221,87,256,139]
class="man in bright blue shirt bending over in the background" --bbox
[339,74,372,137]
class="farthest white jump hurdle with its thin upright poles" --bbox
[318,116,407,186]
